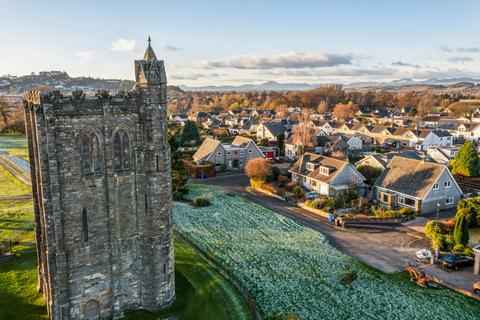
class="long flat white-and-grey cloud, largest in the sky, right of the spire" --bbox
[193,52,353,69]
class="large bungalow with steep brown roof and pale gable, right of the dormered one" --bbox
[374,157,462,214]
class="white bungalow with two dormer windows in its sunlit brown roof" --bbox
[289,153,365,196]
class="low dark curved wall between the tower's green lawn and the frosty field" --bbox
[173,230,262,320]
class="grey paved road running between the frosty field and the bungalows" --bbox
[195,175,428,273]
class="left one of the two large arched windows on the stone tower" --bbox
[80,133,102,176]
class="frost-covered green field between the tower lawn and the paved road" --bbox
[173,185,480,320]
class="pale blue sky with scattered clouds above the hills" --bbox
[0,0,480,86]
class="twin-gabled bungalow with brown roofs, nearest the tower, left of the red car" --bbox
[193,136,264,171]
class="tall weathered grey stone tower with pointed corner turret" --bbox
[24,39,175,319]
